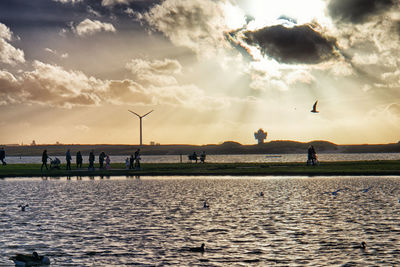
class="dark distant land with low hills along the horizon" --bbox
[4,141,400,156]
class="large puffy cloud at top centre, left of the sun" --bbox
[143,0,245,56]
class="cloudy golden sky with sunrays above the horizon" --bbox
[0,0,400,145]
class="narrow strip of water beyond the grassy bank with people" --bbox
[6,153,400,164]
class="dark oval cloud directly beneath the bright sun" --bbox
[245,25,336,64]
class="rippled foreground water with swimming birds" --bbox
[0,177,400,266]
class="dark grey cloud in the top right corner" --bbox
[328,0,398,23]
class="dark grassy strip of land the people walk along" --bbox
[0,160,400,178]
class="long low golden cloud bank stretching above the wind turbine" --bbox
[0,59,229,109]
